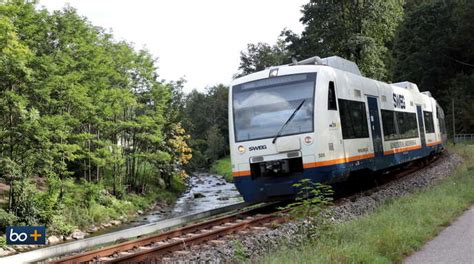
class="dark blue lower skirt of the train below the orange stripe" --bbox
[234,144,443,202]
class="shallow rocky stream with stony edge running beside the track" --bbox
[0,173,242,262]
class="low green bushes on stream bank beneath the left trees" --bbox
[0,171,185,235]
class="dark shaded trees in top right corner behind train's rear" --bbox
[393,1,474,133]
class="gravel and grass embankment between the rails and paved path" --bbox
[169,145,474,263]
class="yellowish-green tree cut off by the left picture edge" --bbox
[0,17,37,210]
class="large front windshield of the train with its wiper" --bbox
[232,73,316,142]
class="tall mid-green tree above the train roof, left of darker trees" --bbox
[282,0,403,80]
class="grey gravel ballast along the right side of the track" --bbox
[163,152,463,263]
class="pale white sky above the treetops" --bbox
[40,0,309,92]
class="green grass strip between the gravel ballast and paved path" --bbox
[259,144,474,263]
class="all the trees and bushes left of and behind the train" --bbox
[0,0,474,243]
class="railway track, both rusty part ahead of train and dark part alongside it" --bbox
[51,154,437,263]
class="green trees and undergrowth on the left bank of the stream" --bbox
[0,0,191,234]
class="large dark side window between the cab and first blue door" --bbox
[339,99,369,139]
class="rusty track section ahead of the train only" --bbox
[50,204,284,263]
